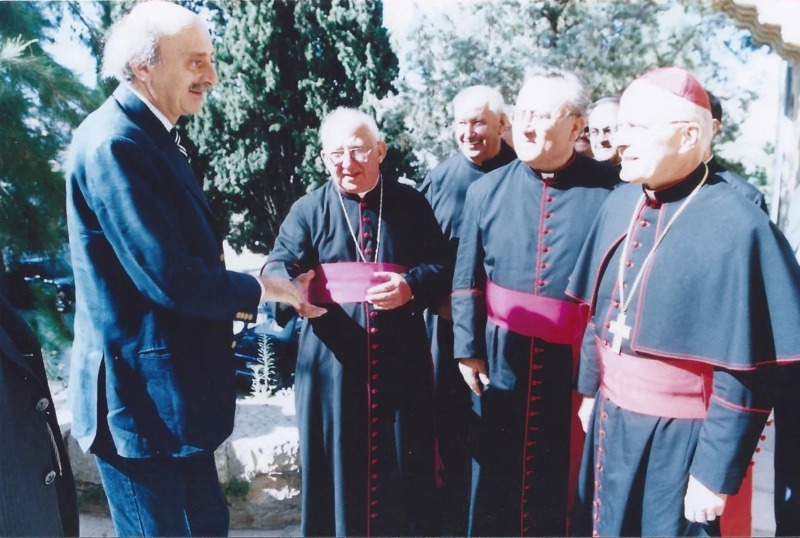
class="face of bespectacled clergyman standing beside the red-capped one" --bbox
[511,79,585,171]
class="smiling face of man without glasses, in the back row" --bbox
[454,102,505,166]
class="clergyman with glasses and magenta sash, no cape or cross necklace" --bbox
[451,68,617,536]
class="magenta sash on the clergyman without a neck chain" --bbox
[486,281,589,345]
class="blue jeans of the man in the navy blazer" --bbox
[95,453,230,536]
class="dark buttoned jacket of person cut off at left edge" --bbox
[0,296,78,536]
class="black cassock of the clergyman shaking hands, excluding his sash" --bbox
[264,176,449,536]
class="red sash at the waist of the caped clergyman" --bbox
[597,341,714,419]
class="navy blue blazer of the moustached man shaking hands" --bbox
[67,85,261,457]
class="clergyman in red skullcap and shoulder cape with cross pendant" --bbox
[567,68,800,536]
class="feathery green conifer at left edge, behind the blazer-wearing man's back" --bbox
[0,2,91,265]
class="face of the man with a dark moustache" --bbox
[132,22,219,123]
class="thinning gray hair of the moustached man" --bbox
[102,0,205,82]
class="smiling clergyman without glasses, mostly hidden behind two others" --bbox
[420,85,517,536]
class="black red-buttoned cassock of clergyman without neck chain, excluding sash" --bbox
[451,155,618,536]
